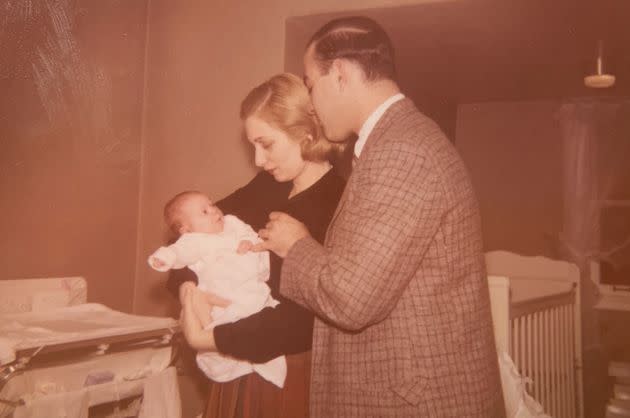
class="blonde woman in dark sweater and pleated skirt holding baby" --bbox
[169,74,344,418]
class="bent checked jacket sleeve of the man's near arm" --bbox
[280,143,446,330]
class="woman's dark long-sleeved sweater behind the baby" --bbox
[168,170,345,363]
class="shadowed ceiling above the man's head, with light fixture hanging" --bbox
[287,0,630,103]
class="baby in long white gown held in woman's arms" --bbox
[148,191,286,387]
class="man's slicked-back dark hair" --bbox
[307,16,396,81]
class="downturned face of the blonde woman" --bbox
[245,116,305,182]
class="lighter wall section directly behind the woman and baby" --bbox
[134,0,436,314]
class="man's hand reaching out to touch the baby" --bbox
[252,212,310,258]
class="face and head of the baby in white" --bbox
[180,195,223,234]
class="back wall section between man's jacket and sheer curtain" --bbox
[455,101,563,258]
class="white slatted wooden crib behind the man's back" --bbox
[486,251,584,418]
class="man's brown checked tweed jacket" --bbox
[280,99,505,418]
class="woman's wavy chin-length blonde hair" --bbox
[241,73,343,161]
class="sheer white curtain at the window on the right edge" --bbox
[559,100,630,343]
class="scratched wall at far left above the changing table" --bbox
[0,0,147,311]
